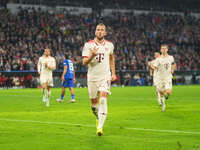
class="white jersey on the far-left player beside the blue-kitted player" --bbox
[37,56,56,76]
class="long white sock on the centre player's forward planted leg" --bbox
[97,97,107,128]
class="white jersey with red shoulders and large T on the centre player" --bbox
[82,40,114,81]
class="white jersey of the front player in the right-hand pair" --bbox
[152,55,174,81]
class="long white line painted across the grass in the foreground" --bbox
[0,118,200,135]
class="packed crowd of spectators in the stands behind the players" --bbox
[0,8,200,86]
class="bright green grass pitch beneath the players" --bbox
[0,86,200,150]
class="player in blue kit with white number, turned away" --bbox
[57,54,76,103]
